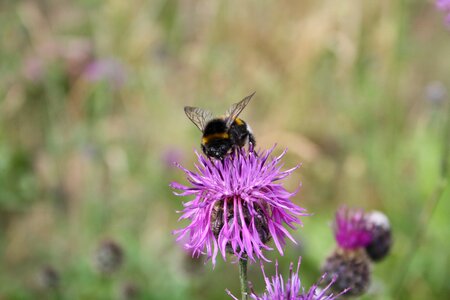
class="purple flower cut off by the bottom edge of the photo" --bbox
[227,257,348,300]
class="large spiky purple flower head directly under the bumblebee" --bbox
[171,148,307,265]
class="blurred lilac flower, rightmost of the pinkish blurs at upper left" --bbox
[84,58,126,88]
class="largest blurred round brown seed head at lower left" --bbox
[94,240,123,274]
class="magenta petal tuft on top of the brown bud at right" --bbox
[334,206,372,249]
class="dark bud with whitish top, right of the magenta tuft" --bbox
[365,211,392,262]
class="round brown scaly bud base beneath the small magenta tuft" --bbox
[322,248,371,296]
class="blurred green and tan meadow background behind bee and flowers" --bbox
[0,0,450,299]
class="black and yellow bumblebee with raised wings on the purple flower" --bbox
[184,93,256,159]
